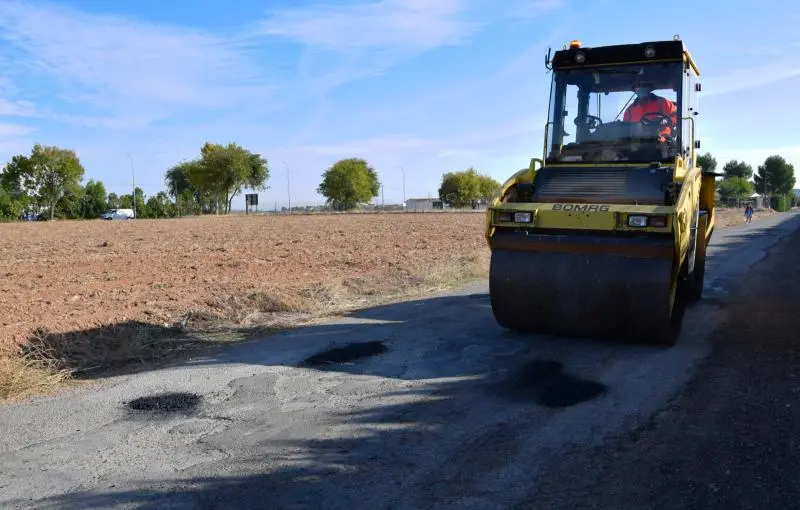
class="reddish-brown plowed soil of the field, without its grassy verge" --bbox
[0,213,488,345]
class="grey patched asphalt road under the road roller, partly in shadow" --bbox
[0,214,800,509]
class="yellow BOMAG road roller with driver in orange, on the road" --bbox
[486,36,718,345]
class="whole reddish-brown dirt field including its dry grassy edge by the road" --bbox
[0,205,776,400]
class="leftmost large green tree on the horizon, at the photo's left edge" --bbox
[4,143,84,219]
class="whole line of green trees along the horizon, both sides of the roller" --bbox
[0,143,795,223]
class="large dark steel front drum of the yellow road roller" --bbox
[489,232,683,344]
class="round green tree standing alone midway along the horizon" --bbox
[317,158,380,210]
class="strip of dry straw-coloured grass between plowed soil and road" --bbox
[0,253,488,401]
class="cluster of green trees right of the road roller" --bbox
[697,153,798,204]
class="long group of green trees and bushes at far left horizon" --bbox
[0,143,269,219]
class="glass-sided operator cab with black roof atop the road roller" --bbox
[545,40,697,163]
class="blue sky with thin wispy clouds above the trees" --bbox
[0,0,800,209]
